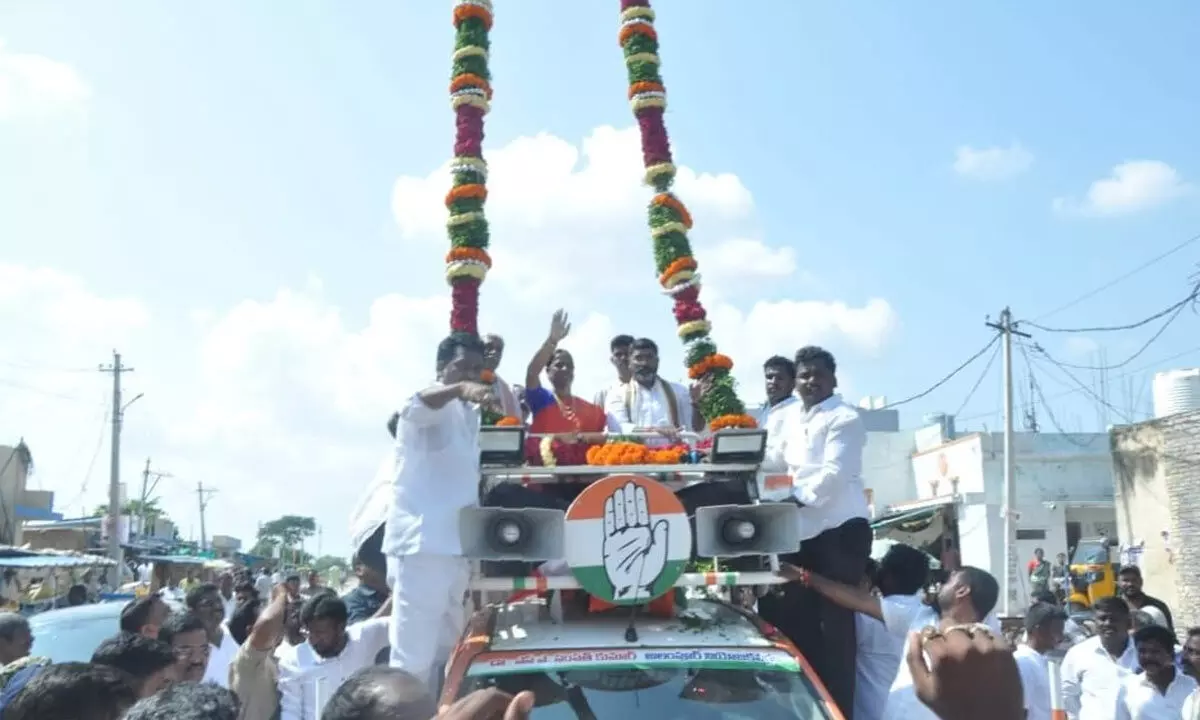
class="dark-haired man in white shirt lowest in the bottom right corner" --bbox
[1116,624,1200,720]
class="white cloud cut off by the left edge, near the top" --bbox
[0,41,89,120]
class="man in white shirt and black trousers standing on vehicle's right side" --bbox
[758,346,871,719]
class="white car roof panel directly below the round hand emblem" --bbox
[488,600,775,652]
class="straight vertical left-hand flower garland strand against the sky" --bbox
[445,0,499,338]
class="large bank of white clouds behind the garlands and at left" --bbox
[0,128,896,552]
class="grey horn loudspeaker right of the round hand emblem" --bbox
[696,503,800,558]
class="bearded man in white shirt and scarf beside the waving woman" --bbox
[604,337,704,444]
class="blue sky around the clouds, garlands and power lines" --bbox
[0,0,1200,552]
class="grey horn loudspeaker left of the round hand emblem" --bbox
[458,508,565,562]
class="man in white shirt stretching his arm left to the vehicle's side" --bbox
[780,563,1001,720]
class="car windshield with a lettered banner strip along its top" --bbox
[460,650,830,720]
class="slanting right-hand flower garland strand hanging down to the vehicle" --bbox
[619,0,756,430]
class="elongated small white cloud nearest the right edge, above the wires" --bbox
[1054,160,1195,217]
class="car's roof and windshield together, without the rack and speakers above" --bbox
[443,592,841,720]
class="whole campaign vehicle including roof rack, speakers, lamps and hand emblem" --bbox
[451,426,842,720]
